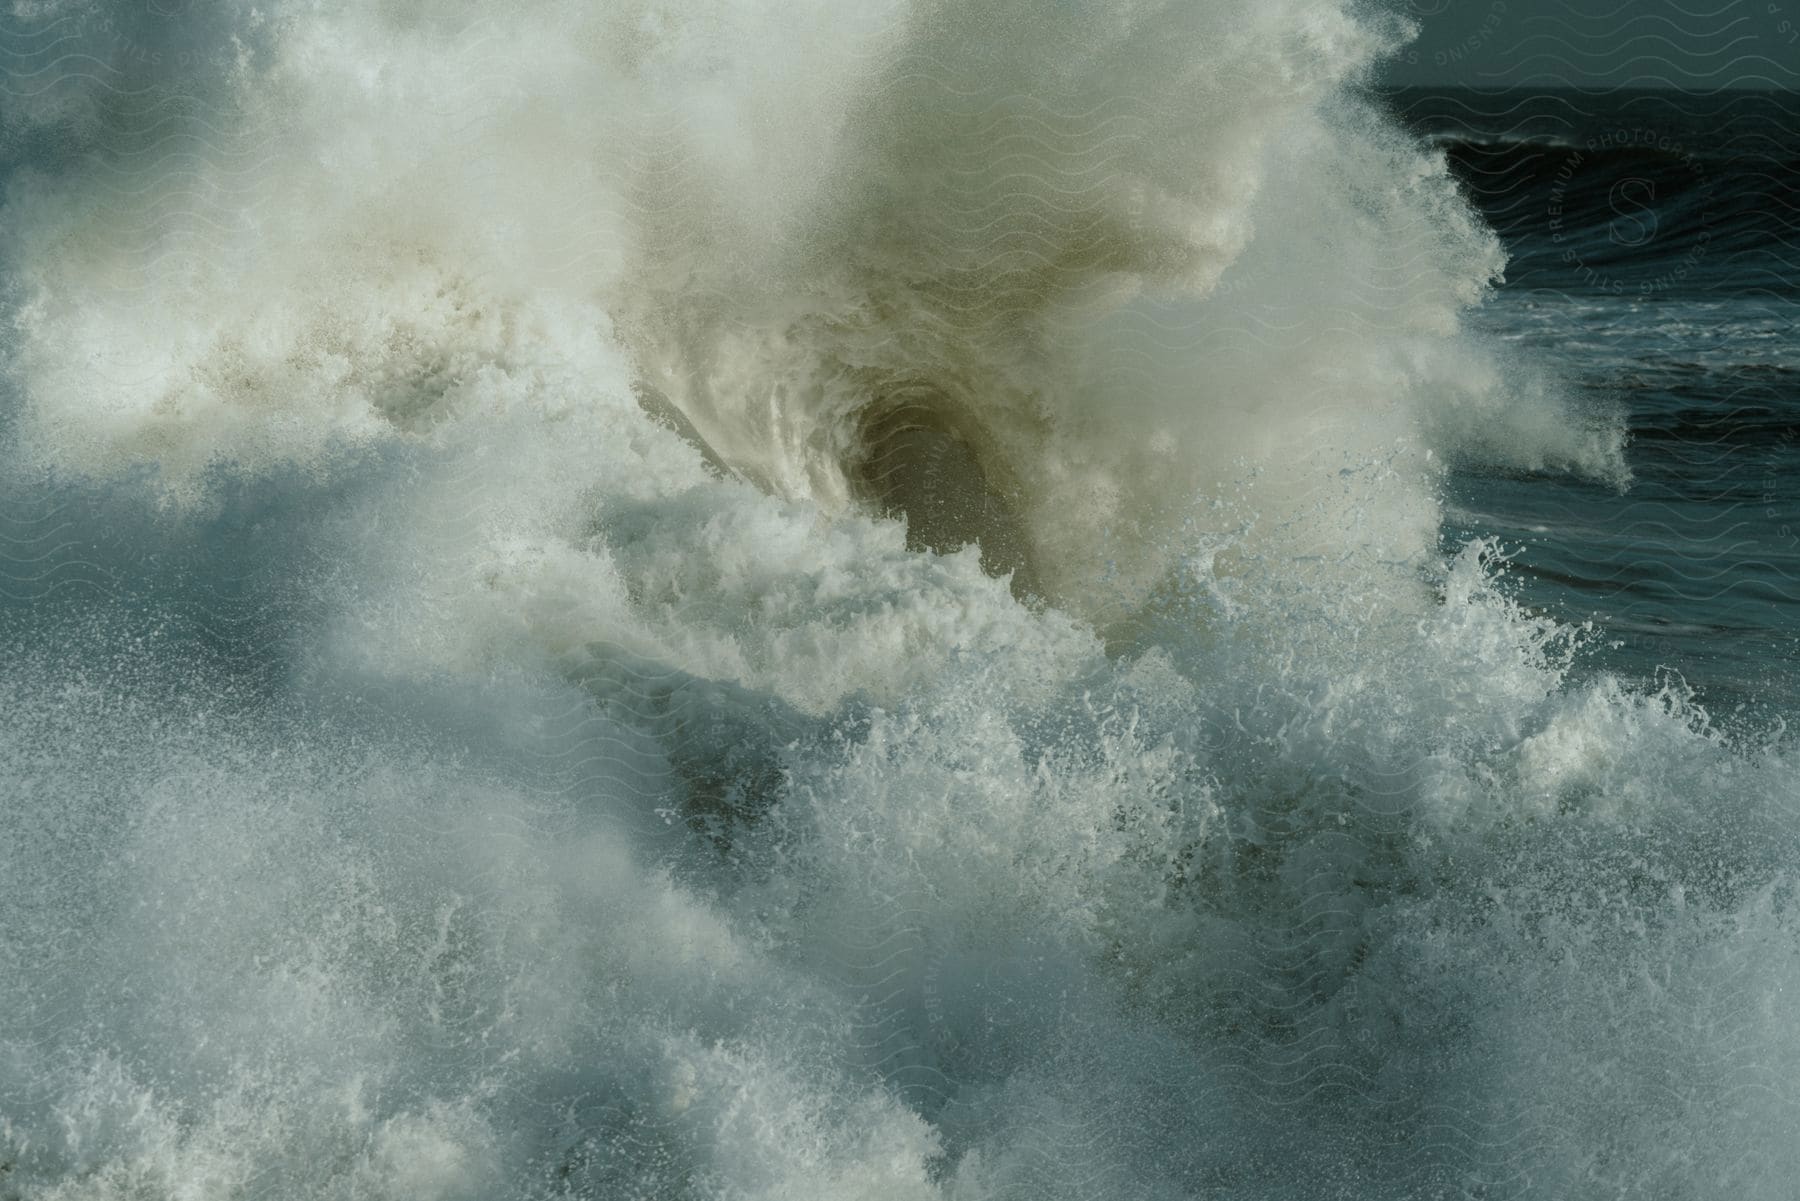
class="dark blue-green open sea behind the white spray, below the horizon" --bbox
[1393,90,1800,720]
